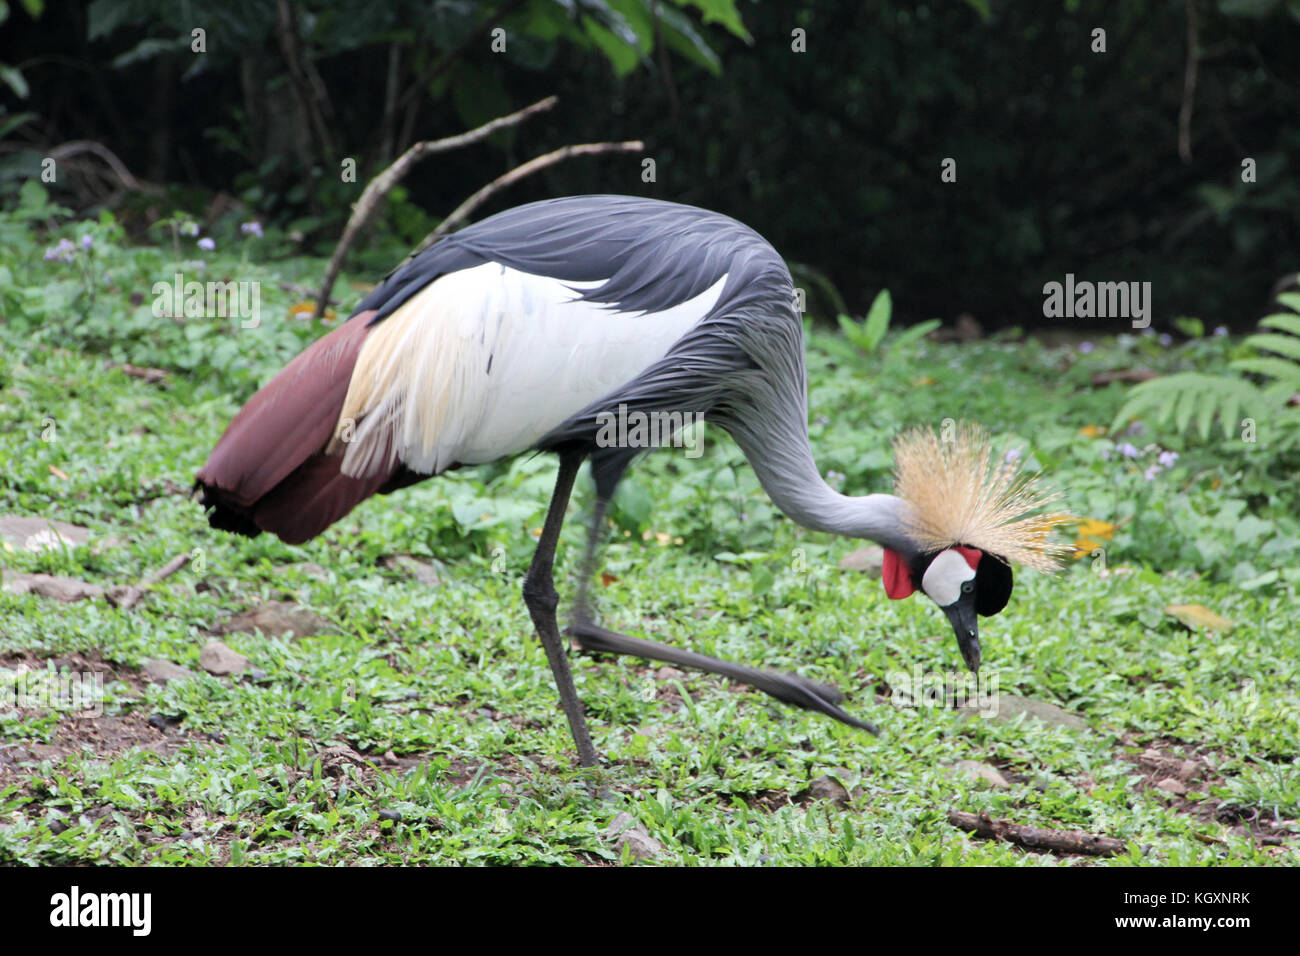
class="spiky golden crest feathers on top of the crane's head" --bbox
[894,423,1070,571]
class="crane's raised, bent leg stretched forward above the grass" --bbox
[566,494,878,734]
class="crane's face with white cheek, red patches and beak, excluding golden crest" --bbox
[884,545,1011,671]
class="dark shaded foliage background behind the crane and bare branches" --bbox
[0,0,1300,326]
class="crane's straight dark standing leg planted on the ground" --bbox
[524,451,598,767]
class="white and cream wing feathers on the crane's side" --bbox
[335,263,727,477]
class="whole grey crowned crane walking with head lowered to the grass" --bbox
[195,195,1062,766]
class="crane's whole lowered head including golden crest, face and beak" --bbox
[884,424,1069,671]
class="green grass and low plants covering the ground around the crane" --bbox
[0,208,1300,866]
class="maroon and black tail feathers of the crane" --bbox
[194,311,424,544]
